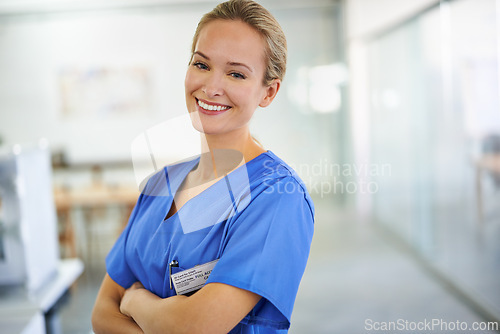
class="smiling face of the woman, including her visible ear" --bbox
[185,20,280,135]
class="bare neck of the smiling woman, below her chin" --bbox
[196,127,265,180]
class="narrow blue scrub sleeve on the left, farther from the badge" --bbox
[106,194,144,289]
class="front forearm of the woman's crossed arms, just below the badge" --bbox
[120,283,261,334]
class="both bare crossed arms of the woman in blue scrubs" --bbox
[92,274,261,334]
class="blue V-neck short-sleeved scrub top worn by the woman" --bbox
[106,151,314,333]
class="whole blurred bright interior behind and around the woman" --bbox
[0,0,500,333]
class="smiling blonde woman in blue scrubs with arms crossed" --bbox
[92,0,314,333]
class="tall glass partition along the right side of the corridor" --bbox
[368,0,500,315]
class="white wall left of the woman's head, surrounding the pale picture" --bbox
[0,7,209,161]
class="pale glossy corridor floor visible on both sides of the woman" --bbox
[60,199,493,334]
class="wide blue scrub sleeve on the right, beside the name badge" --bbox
[207,176,314,329]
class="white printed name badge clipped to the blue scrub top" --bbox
[172,259,219,295]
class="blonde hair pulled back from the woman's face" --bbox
[191,0,287,86]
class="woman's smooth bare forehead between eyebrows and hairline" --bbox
[195,20,265,66]
